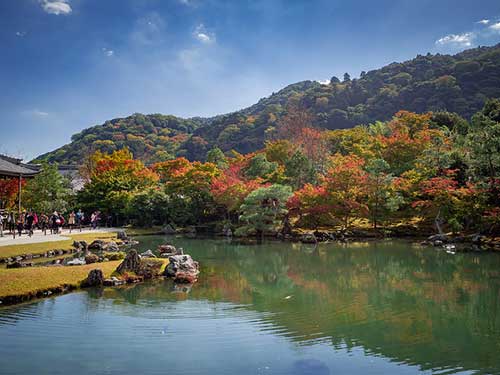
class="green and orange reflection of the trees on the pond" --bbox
[86,236,500,373]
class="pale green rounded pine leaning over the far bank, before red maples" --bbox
[236,184,292,237]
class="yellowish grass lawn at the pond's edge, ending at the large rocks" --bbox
[0,260,121,298]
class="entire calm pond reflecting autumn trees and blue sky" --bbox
[0,236,500,375]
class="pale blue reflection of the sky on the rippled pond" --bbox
[0,292,468,375]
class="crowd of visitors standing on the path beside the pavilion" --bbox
[0,210,99,238]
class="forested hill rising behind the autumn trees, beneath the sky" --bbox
[36,44,500,163]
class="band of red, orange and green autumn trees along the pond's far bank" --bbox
[9,99,500,238]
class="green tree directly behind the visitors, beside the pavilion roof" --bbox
[23,163,73,214]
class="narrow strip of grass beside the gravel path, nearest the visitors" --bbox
[0,232,116,258]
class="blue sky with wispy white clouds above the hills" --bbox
[0,0,500,159]
